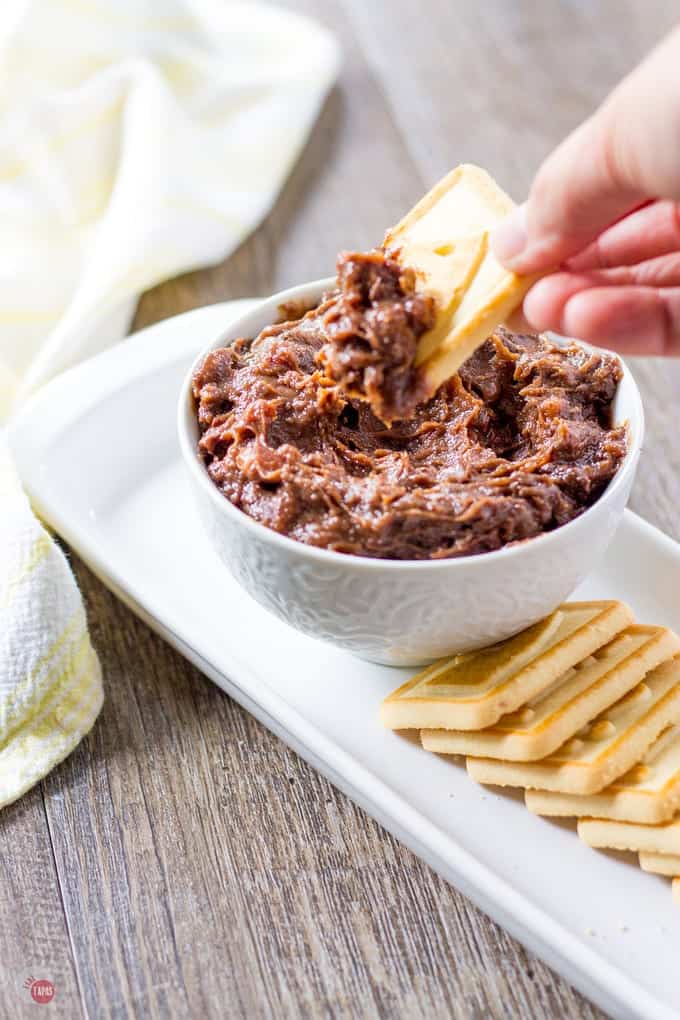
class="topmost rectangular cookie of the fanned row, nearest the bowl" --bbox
[380,601,632,729]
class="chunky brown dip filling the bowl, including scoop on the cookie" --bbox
[193,252,626,560]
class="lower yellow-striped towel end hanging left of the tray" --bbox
[0,436,103,806]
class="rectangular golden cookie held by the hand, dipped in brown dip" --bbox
[382,163,535,392]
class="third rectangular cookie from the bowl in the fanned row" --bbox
[467,657,680,791]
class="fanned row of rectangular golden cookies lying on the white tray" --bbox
[381,601,680,902]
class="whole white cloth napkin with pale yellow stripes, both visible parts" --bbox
[0,0,338,806]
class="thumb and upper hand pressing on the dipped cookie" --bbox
[492,30,680,273]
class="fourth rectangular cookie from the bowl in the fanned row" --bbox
[524,726,680,828]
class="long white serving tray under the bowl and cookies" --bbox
[9,302,680,1020]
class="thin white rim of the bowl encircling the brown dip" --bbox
[177,276,644,571]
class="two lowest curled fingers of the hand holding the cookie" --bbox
[524,273,680,355]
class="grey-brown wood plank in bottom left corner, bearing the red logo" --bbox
[0,786,84,1020]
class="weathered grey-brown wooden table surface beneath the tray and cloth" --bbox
[0,0,680,1020]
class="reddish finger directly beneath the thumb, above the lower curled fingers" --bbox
[567,201,680,272]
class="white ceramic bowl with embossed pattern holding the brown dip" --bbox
[178,279,644,666]
